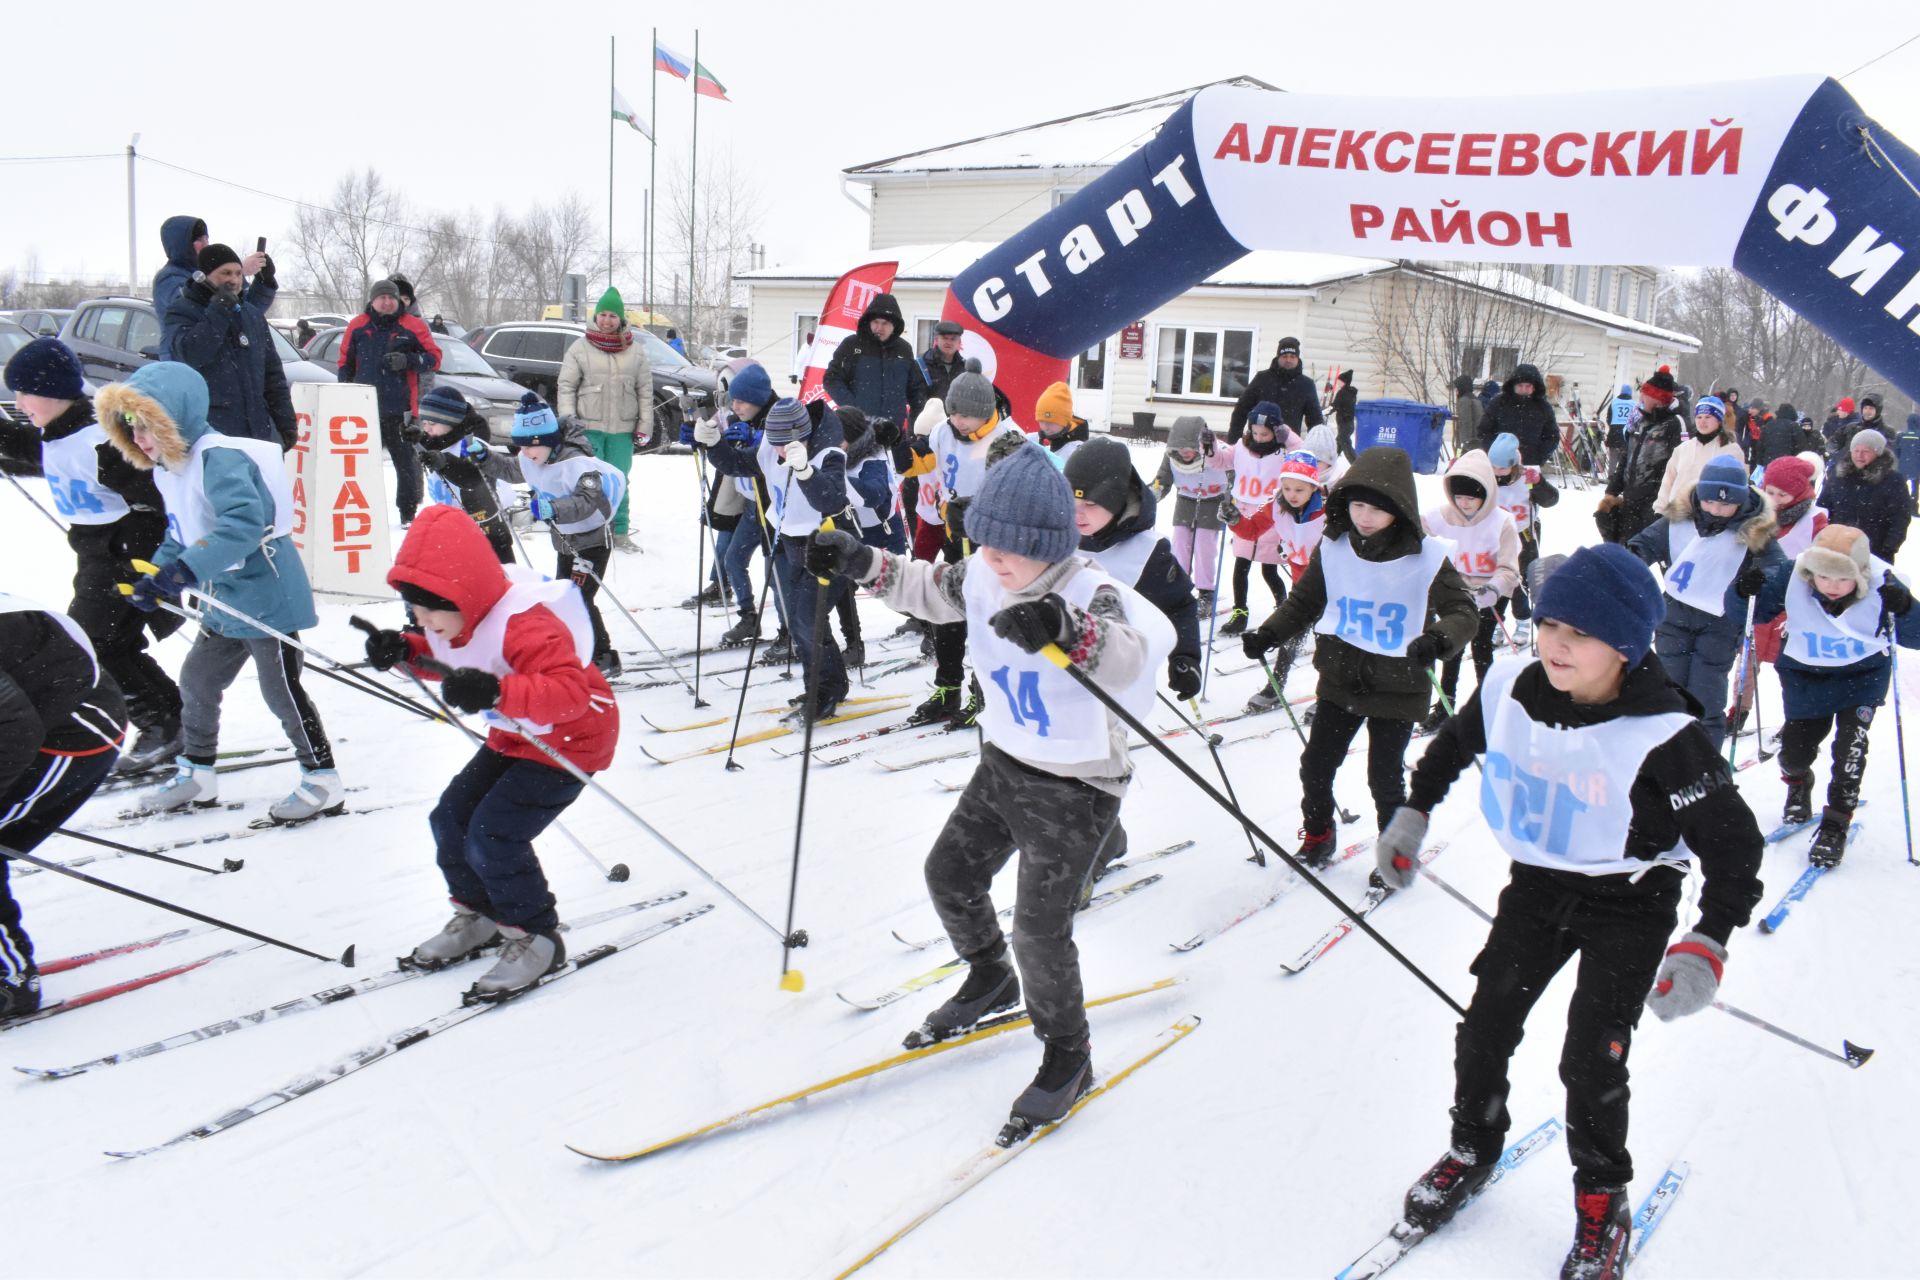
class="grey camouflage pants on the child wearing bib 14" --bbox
[927,743,1119,1042]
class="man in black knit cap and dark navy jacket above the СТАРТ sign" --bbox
[163,244,298,451]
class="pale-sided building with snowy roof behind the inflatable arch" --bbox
[741,77,1699,441]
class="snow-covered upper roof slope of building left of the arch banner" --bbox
[847,75,1273,178]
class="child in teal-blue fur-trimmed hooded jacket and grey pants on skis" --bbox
[94,361,346,821]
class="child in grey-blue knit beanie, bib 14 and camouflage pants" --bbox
[806,443,1173,1125]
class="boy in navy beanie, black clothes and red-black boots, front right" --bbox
[1375,545,1764,1276]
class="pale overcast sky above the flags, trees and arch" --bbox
[0,0,1920,293]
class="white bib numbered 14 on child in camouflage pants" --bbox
[962,553,1173,764]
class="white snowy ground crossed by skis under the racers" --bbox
[0,451,1920,1278]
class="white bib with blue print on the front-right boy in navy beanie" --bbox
[1480,656,1693,875]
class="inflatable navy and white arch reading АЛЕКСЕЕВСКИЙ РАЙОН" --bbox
[943,77,1920,416]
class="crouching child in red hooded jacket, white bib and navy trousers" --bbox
[367,507,620,1000]
